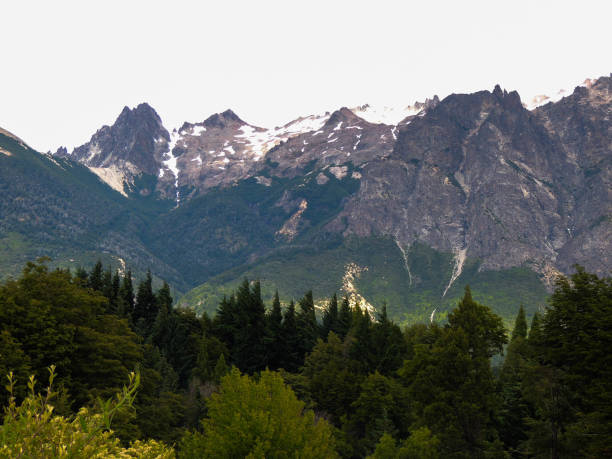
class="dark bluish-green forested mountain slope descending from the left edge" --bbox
[0,131,181,285]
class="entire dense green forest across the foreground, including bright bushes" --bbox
[0,260,612,458]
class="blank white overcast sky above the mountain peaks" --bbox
[0,0,612,151]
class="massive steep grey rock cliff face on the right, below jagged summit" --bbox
[329,78,612,286]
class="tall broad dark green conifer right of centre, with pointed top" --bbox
[400,287,506,457]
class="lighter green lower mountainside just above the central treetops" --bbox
[180,237,548,325]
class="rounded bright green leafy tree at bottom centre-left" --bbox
[180,369,337,459]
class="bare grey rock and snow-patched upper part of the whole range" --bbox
[56,77,612,286]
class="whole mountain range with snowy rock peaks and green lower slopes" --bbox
[0,76,612,322]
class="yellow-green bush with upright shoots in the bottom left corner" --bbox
[0,367,174,459]
